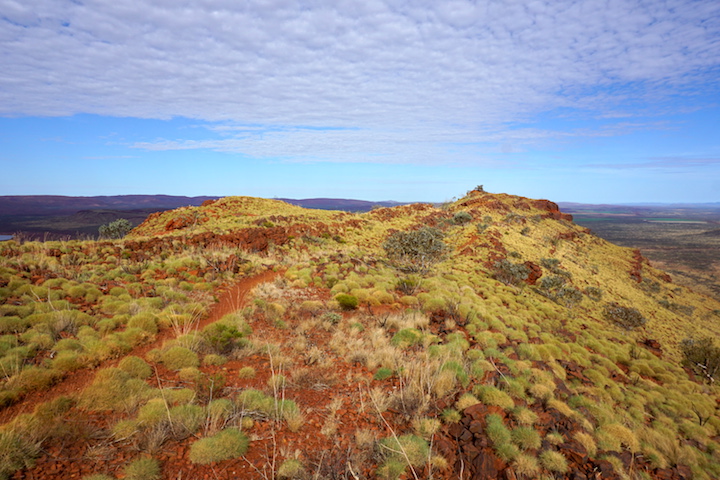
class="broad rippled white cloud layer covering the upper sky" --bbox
[0,0,720,161]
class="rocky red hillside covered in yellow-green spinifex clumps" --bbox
[0,191,720,480]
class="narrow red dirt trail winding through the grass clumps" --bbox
[0,270,279,424]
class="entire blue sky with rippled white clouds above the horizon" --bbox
[0,0,720,203]
